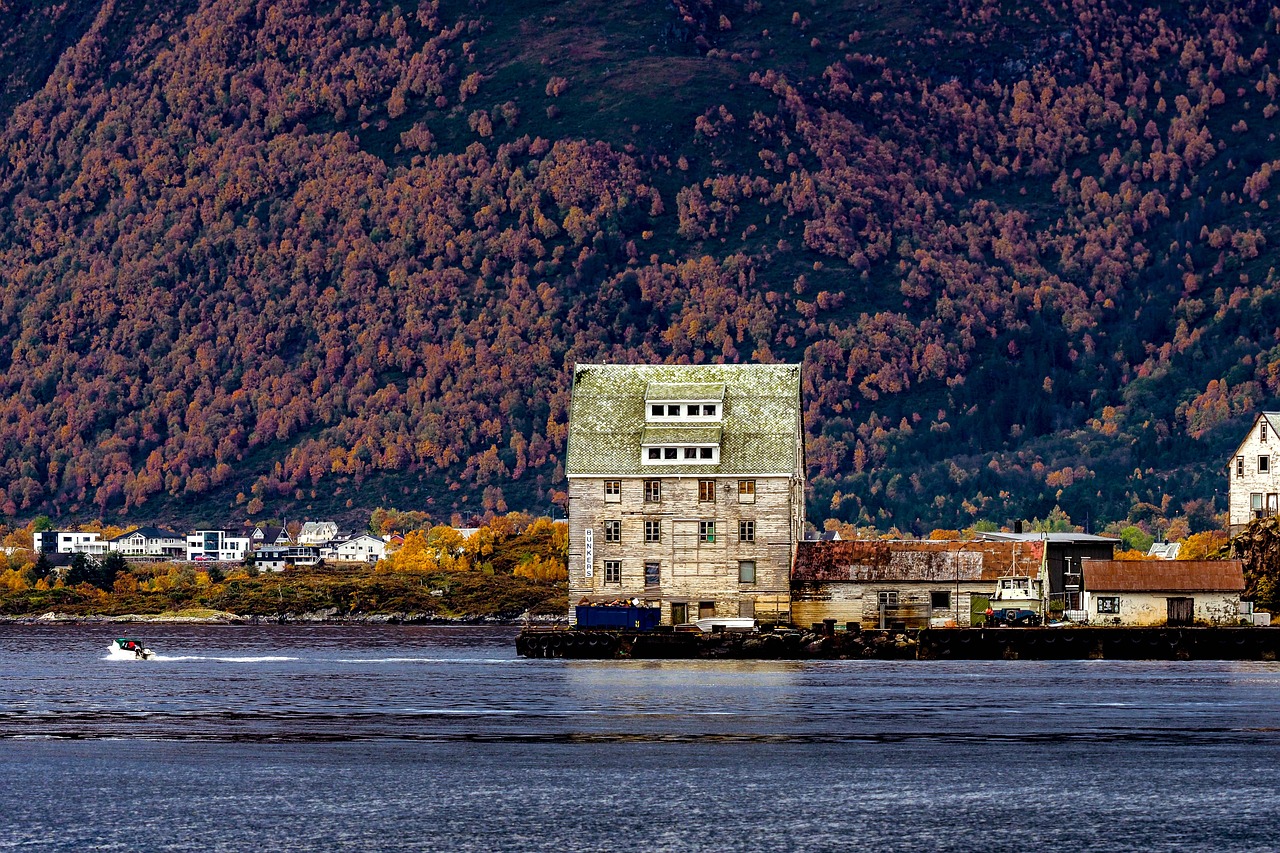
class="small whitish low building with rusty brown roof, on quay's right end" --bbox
[1083,560,1244,625]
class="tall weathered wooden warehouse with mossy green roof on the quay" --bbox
[564,364,805,624]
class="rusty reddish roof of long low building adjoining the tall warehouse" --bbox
[791,539,1044,583]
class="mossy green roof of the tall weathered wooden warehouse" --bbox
[564,364,801,476]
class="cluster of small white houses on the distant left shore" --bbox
[33,521,390,571]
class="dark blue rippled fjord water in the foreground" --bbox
[0,625,1280,850]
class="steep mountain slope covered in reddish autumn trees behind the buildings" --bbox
[0,0,1280,529]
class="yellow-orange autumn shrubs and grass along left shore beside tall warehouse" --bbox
[0,511,568,620]
